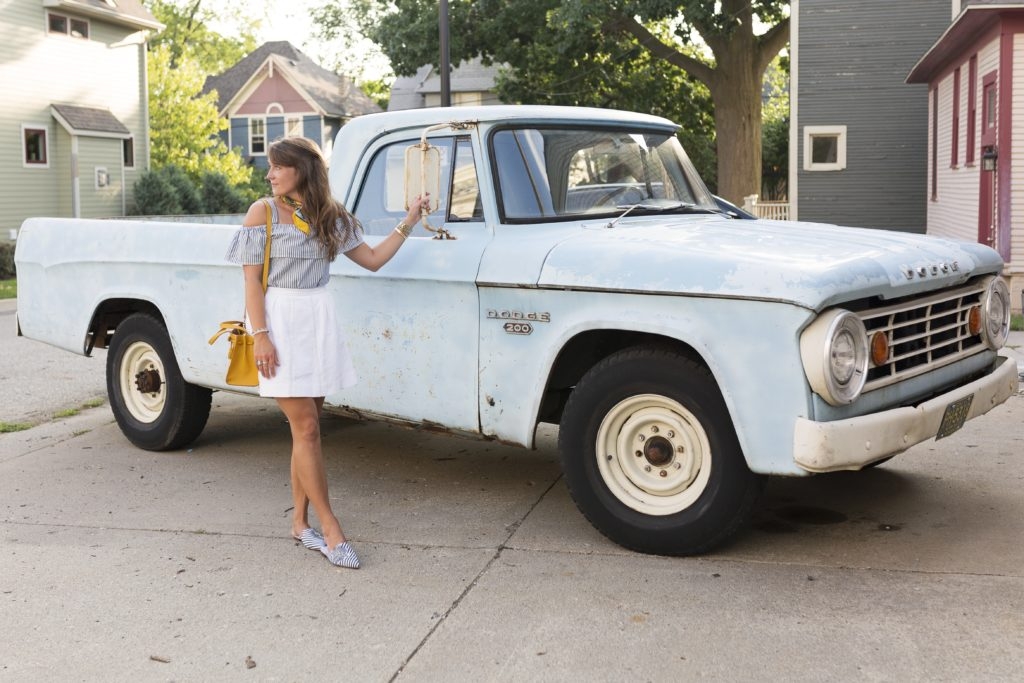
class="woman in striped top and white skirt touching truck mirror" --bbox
[226,137,426,568]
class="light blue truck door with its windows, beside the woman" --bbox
[328,134,492,432]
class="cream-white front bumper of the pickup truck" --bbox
[794,356,1020,472]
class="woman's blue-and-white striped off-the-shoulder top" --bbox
[224,202,362,290]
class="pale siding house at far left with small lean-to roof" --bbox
[0,0,163,232]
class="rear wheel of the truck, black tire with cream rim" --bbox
[106,313,212,451]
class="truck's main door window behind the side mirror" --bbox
[352,137,454,237]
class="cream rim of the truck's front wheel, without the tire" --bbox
[596,394,712,515]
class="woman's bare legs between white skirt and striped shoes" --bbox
[276,398,345,548]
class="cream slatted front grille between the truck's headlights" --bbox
[857,283,986,391]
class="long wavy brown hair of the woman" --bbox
[266,136,359,259]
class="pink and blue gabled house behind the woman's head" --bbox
[203,41,380,168]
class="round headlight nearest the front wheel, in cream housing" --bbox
[800,309,869,405]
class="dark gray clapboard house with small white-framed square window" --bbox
[790,0,951,232]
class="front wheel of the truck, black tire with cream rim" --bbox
[558,346,765,555]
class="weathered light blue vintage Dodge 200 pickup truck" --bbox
[15,106,1018,555]
